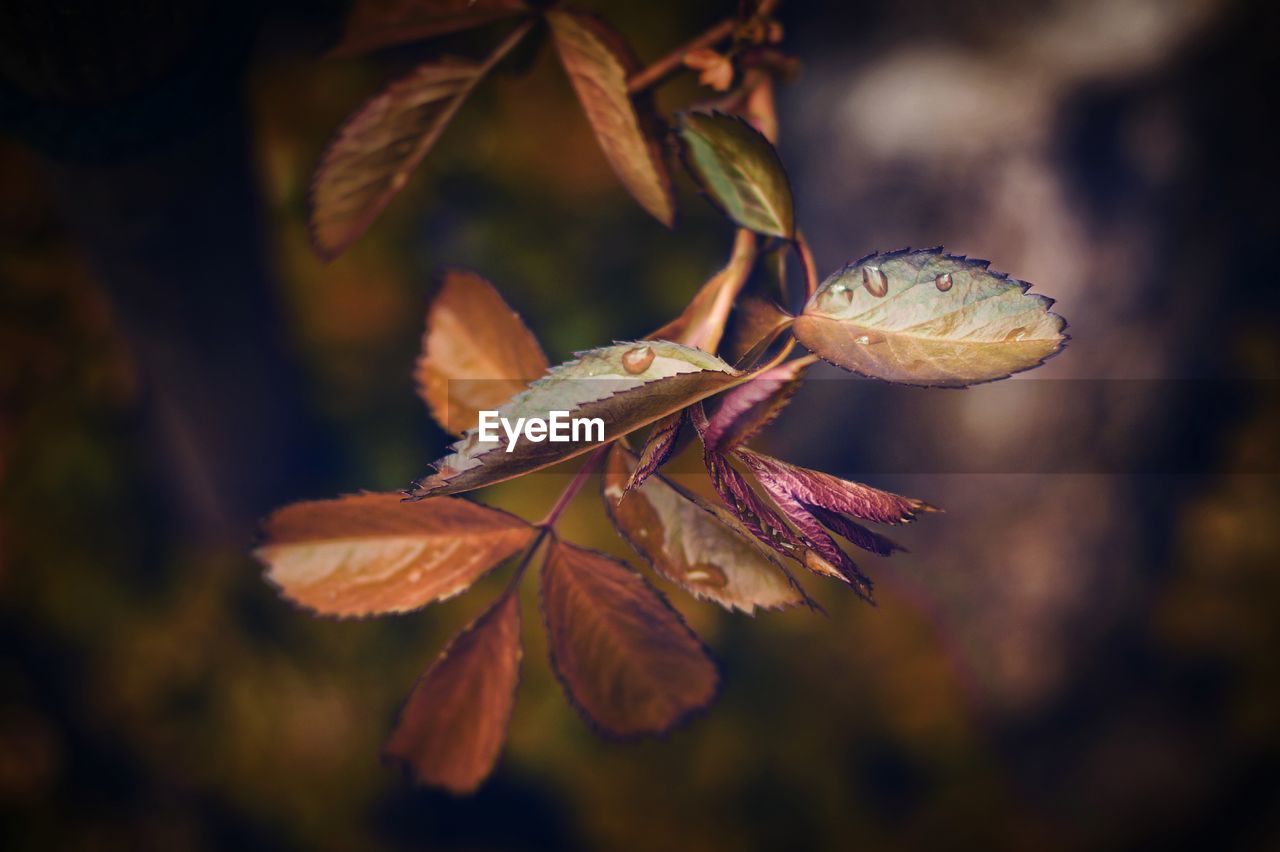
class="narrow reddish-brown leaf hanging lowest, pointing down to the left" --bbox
[384,594,524,794]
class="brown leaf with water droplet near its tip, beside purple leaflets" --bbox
[602,445,805,613]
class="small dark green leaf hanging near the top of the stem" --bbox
[680,113,795,239]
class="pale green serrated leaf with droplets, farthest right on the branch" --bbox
[792,248,1068,388]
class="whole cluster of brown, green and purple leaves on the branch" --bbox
[255,0,1066,792]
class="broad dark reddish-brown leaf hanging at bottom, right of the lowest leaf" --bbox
[540,540,719,737]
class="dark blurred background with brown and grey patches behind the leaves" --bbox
[0,0,1280,849]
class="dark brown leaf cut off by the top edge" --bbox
[330,0,529,56]
